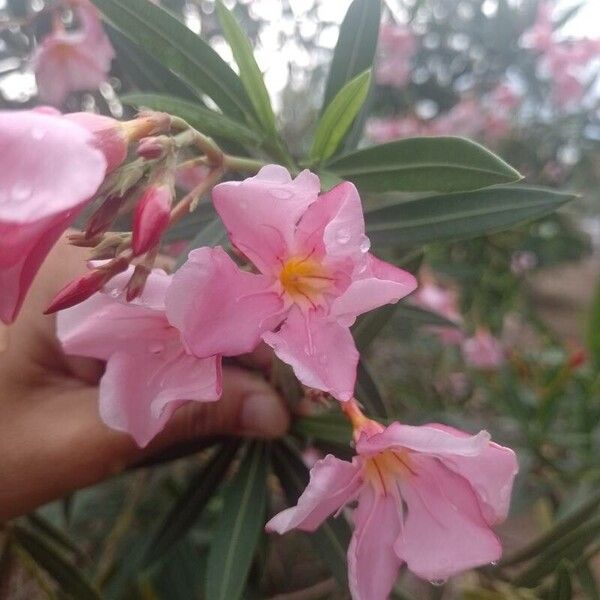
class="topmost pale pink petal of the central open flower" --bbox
[212,165,320,273]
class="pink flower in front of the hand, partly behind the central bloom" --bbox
[57,267,221,446]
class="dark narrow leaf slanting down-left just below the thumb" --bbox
[142,440,240,565]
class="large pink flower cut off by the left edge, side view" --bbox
[0,111,106,323]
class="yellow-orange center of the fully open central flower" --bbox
[279,257,333,305]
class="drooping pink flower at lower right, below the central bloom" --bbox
[266,417,518,600]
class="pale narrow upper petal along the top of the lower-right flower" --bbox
[356,423,490,458]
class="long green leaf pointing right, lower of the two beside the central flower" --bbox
[365,186,575,247]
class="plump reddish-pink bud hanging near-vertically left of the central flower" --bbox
[132,184,172,256]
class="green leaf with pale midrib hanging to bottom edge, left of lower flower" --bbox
[206,442,269,600]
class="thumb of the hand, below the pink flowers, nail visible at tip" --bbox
[151,367,289,447]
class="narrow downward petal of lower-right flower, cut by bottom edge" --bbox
[348,486,403,600]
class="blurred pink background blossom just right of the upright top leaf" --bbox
[375,24,416,87]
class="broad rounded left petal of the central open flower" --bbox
[166,247,283,357]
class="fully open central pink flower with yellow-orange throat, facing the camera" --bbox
[167,165,416,400]
